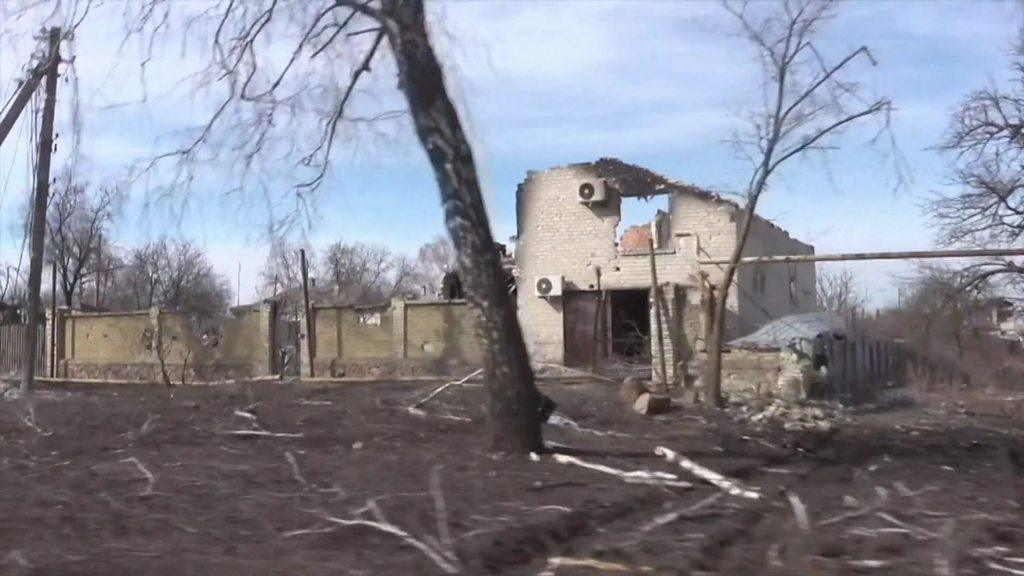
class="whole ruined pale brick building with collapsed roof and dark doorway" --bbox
[516,159,816,380]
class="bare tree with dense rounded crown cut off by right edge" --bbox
[928,39,1024,294]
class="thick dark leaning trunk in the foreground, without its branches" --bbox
[383,0,543,453]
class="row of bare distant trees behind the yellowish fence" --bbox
[0,166,455,316]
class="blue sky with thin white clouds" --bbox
[0,1,1024,305]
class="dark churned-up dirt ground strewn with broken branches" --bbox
[0,383,1024,576]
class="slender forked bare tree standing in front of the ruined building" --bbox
[705,0,892,406]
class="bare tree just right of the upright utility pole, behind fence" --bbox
[46,170,122,306]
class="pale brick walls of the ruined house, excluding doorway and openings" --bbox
[516,160,814,377]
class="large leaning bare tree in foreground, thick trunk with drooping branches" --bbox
[113,0,550,453]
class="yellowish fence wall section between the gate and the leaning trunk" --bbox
[302,300,482,378]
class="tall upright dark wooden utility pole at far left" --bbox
[22,27,60,395]
